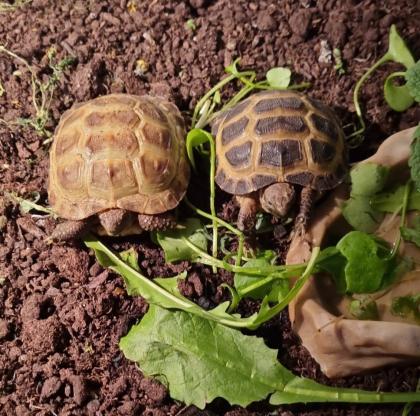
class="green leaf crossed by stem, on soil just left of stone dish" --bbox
[234,257,290,302]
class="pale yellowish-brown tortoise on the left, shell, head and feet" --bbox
[48,94,190,240]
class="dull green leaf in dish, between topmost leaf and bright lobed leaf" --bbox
[342,196,384,233]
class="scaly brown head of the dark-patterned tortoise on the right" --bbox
[260,182,296,218]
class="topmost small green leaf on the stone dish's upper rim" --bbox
[350,163,389,196]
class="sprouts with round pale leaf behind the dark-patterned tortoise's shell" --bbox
[191,58,310,128]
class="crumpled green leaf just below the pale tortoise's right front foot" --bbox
[154,218,207,263]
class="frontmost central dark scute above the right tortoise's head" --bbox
[260,140,303,167]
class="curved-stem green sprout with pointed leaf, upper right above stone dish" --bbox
[348,25,420,145]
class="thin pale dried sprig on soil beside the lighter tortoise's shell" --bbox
[0,45,74,144]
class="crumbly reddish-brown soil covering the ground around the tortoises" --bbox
[0,0,420,416]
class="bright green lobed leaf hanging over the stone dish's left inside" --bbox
[337,231,388,293]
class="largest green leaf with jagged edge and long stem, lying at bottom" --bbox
[120,305,420,409]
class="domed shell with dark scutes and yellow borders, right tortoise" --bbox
[212,91,347,195]
